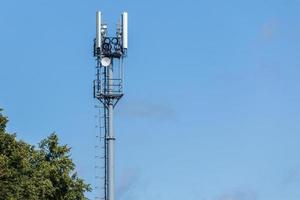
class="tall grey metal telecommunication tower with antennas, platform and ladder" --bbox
[93,11,128,200]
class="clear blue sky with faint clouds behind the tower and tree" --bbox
[0,0,300,200]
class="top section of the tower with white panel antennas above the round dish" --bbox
[94,11,128,58]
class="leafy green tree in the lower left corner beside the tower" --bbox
[0,109,91,200]
